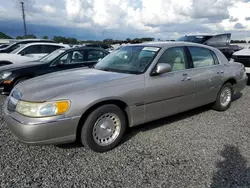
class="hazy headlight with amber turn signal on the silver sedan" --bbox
[16,100,70,117]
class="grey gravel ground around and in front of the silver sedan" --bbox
[0,86,250,188]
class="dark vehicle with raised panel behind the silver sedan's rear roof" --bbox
[177,33,242,59]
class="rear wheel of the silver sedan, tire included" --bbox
[213,83,233,111]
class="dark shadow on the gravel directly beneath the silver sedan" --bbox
[57,93,243,149]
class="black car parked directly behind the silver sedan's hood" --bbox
[0,47,108,95]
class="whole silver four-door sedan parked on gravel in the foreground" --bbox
[4,42,247,152]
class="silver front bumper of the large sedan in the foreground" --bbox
[3,99,80,145]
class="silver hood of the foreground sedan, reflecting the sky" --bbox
[16,68,135,102]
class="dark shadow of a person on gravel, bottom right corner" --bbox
[211,145,250,188]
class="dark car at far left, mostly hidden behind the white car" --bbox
[0,39,55,53]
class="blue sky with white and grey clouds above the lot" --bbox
[0,0,250,40]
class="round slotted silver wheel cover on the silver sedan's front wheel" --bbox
[92,113,121,146]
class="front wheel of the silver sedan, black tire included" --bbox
[81,104,127,152]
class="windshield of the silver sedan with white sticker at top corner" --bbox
[95,46,160,74]
